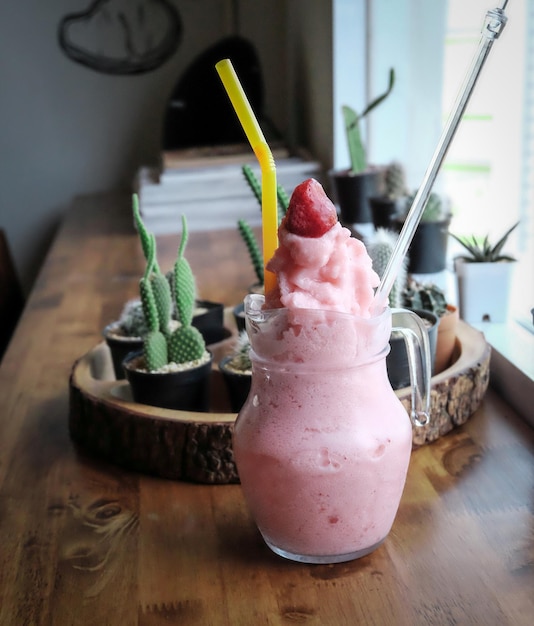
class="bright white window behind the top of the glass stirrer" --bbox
[442,0,534,324]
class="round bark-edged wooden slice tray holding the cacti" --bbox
[69,322,490,484]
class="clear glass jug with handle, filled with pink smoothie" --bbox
[233,295,430,563]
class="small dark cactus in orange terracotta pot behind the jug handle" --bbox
[402,278,459,374]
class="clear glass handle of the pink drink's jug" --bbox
[392,309,432,427]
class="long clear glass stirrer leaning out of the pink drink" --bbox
[373,0,508,312]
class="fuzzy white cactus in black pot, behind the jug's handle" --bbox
[367,228,438,389]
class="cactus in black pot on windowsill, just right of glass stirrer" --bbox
[393,191,451,274]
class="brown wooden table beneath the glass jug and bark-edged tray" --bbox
[0,195,534,626]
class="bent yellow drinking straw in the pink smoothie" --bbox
[215,59,278,293]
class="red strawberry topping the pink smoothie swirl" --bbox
[282,178,337,238]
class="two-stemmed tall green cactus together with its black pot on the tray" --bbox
[124,209,212,411]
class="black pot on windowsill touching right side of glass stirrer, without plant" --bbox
[395,217,451,274]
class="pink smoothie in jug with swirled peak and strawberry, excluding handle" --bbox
[234,181,412,563]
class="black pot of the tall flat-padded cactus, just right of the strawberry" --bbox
[329,169,384,224]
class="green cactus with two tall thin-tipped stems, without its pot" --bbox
[134,196,206,371]
